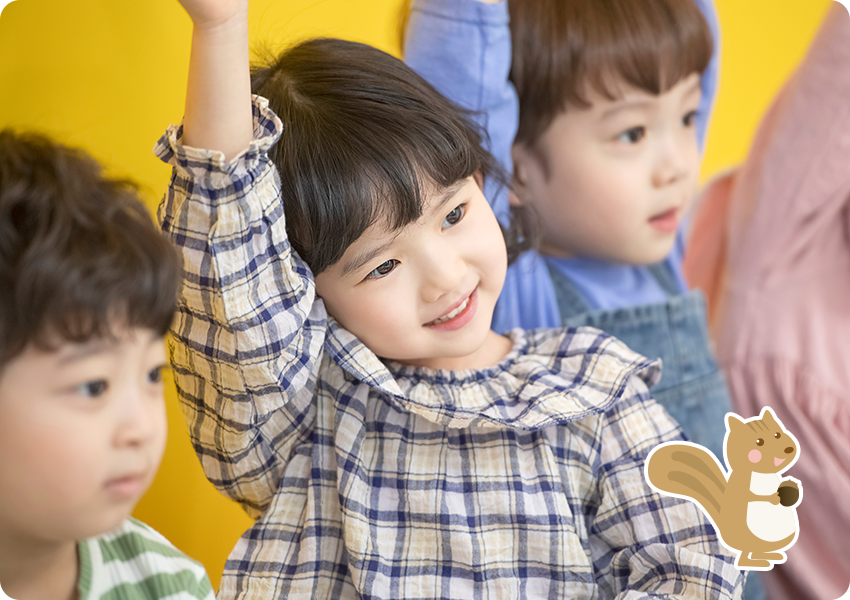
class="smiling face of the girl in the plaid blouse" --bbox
[316,177,507,369]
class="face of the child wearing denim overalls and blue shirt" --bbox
[513,74,700,264]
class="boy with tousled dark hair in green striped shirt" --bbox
[0,130,213,600]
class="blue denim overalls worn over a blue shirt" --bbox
[549,263,764,600]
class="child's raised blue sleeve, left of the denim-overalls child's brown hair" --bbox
[404,0,519,224]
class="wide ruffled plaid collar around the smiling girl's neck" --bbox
[325,318,661,430]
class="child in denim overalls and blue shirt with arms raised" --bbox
[404,0,762,600]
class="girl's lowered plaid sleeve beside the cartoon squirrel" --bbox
[588,378,744,600]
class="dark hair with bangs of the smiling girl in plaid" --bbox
[251,38,531,274]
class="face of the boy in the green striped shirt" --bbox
[0,329,166,544]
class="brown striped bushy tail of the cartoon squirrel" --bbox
[646,444,726,523]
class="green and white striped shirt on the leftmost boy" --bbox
[78,519,214,600]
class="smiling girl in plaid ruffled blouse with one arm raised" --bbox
[158,0,741,599]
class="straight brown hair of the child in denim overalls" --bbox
[508,0,713,146]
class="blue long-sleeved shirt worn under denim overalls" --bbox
[405,0,719,332]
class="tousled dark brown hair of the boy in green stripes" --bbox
[0,130,181,370]
